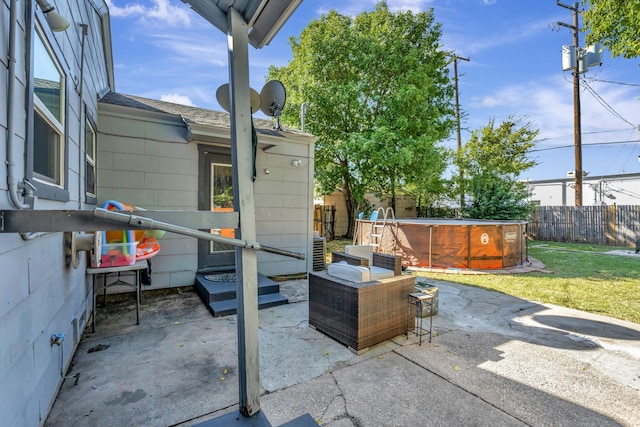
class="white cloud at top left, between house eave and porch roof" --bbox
[106,0,191,26]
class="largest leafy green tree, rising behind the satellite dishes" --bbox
[268,2,454,235]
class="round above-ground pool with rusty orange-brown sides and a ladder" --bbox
[356,218,527,269]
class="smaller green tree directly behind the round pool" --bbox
[456,117,538,219]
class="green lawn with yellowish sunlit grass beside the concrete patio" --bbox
[327,240,640,323]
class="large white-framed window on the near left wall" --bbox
[33,26,65,188]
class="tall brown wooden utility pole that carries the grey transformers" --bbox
[556,1,582,206]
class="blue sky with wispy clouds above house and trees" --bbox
[107,0,640,180]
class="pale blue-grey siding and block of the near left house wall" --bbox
[0,0,112,426]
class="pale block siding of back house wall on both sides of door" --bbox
[98,95,313,289]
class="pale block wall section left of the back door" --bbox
[97,104,198,289]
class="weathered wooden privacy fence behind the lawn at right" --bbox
[528,205,640,246]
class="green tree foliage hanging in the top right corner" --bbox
[582,0,640,58]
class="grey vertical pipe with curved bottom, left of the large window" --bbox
[5,0,35,209]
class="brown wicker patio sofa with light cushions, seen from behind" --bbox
[309,247,415,354]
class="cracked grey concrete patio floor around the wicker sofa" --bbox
[46,280,640,427]
